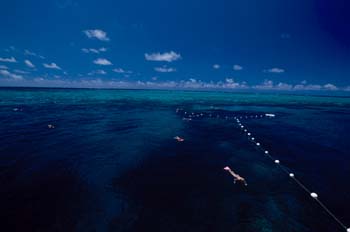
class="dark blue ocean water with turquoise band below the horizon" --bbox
[0,89,350,232]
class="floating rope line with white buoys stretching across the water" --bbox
[176,109,350,232]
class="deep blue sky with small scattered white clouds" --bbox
[0,0,350,91]
